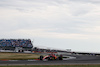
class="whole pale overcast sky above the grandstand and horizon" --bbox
[0,0,100,52]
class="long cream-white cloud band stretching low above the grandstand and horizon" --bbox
[1,29,100,40]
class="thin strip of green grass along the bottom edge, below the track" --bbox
[0,65,100,67]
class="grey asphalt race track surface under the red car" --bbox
[0,55,100,65]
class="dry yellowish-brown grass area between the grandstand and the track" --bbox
[0,52,40,60]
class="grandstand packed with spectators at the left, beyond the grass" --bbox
[0,39,33,51]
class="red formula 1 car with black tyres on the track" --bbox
[39,54,63,60]
